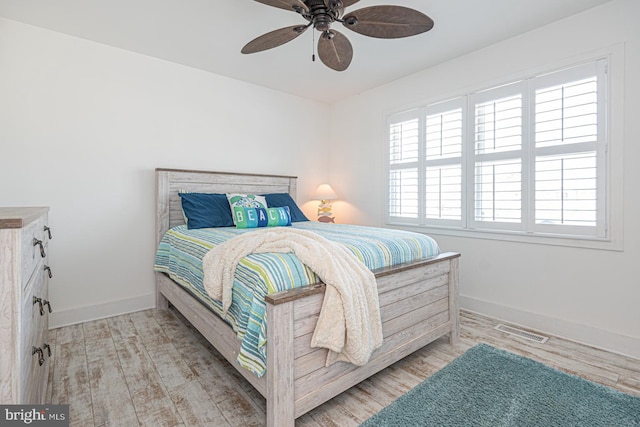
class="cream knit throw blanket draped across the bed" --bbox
[203,227,382,366]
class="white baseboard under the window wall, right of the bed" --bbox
[460,295,640,359]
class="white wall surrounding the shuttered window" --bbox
[330,0,640,357]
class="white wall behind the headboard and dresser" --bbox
[0,19,329,326]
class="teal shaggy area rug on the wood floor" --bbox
[361,344,640,427]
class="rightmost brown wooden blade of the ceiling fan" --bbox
[343,6,433,39]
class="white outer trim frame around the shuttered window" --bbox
[383,43,625,251]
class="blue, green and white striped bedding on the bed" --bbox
[155,221,440,376]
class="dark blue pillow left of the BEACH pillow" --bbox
[180,193,233,230]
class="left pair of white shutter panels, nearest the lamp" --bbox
[388,100,464,226]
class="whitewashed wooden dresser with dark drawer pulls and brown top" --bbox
[0,207,51,404]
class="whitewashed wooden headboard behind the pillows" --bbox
[156,168,297,246]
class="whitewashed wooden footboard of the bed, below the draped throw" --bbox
[266,253,459,426]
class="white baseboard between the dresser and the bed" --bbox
[49,293,156,329]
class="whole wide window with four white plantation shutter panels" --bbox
[387,59,608,239]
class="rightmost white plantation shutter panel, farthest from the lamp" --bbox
[533,61,606,237]
